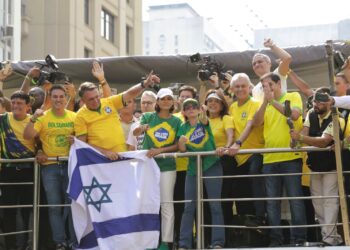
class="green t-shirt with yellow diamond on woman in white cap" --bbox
[140,112,182,171]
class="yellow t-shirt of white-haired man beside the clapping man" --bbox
[230,98,264,166]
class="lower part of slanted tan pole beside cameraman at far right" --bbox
[332,107,350,246]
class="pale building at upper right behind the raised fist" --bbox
[254,19,350,48]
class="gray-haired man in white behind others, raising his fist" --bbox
[252,38,292,102]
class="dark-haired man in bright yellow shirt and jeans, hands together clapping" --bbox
[253,73,306,247]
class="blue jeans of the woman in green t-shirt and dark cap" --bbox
[179,161,225,249]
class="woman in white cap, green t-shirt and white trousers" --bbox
[134,88,182,250]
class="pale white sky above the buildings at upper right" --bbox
[142,0,350,50]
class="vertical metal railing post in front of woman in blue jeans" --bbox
[196,155,203,249]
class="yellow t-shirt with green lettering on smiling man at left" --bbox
[34,109,76,164]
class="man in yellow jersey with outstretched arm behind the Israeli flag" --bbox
[74,72,160,160]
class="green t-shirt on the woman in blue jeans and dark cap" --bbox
[177,122,219,176]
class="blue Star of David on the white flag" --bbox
[83,177,112,212]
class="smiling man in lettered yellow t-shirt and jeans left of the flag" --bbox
[23,84,76,250]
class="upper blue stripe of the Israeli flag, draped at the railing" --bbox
[69,148,131,200]
